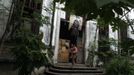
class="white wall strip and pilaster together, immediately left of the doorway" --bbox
[40,0,66,63]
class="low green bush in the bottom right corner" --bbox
[105,56,134,75]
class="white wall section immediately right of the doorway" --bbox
[85,21,98,66]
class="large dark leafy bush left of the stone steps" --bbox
[11,30,53,75]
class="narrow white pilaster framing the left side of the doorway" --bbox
[52,3,66,63]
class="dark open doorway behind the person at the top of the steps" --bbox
[58,19,84,64]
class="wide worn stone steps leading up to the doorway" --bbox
[45,63,104,75]
